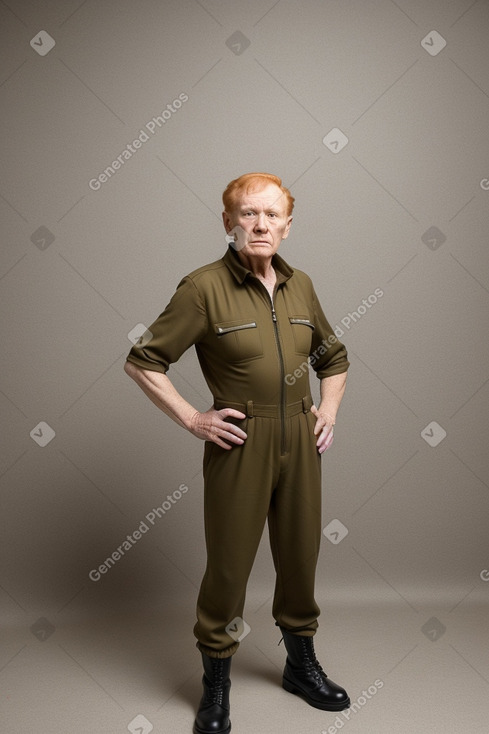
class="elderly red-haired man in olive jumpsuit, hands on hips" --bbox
[125,173,350,734]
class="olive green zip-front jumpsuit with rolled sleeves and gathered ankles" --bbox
[127,247,349,657]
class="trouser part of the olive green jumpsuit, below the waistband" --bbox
[194,411,321,657]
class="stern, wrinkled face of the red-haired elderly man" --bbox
[222,183,292,258]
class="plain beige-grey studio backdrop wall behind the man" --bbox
[0,0,489,731]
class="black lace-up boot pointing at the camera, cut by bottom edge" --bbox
[193,653,231,734]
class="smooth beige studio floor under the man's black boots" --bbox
[0,599,489,734]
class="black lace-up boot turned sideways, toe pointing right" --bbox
[280,627,350,711]
